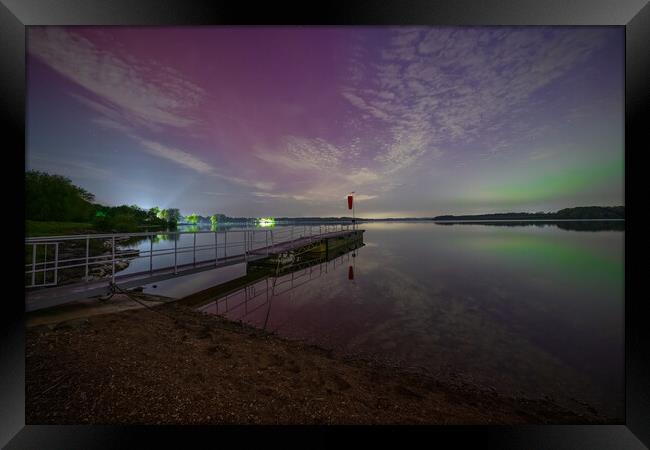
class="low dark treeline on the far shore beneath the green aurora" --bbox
[433,206,625,221]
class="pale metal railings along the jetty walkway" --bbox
[25,224,352,288]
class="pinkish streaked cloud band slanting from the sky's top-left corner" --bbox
[28,27,205,130]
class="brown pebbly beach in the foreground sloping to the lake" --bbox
[25,295,611,424]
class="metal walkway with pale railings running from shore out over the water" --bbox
[25,225,363,311]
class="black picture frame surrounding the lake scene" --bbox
[0,0,650,449]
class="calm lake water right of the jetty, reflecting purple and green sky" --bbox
[135,222,624,420]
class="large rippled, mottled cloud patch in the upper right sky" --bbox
[341,27,605,174]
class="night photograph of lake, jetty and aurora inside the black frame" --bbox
[23,25,629,425]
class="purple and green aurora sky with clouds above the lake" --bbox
[26,26,624,218]
